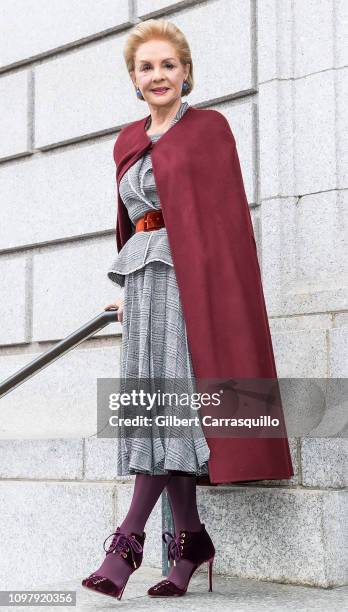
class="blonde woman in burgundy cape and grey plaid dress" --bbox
[82,19,293,599]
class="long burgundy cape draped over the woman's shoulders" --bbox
[113,106,294,485]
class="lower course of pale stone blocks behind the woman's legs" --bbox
[0,439,348,590]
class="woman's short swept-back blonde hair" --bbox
[123,19,194,96]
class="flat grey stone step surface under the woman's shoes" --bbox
[6,567,348,612]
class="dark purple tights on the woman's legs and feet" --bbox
[94,472,201,588]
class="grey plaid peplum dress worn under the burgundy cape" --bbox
[107,102,209,476]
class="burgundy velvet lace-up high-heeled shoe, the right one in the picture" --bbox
[147,523,215,597]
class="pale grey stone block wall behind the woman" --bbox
[0,0,348,589]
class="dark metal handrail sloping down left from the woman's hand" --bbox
[0,308,118,398]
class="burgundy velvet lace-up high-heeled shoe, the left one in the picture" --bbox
[81,527,146,600]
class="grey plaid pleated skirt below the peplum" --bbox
[117,261,210,476]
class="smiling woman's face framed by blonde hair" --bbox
[131,39,190,107]
